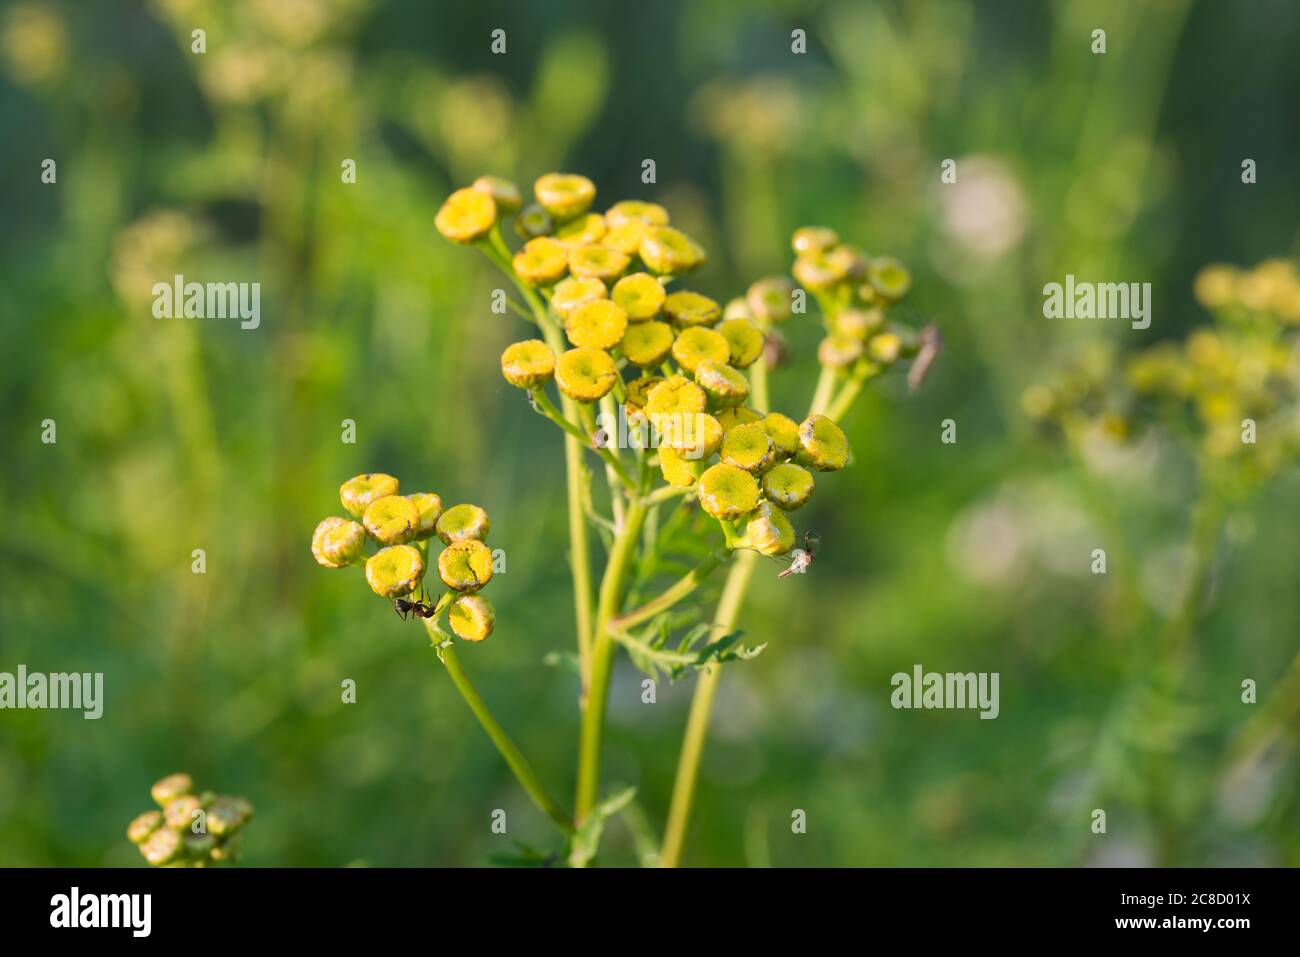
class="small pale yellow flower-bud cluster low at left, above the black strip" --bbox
[126,774,252,867]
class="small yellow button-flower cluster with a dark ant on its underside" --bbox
[312,472,495,641]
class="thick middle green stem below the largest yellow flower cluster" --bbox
[575,498,646,824]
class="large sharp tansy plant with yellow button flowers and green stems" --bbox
[313,173,937,866]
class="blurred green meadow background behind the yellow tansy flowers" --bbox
[0,0,1300,866]
